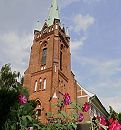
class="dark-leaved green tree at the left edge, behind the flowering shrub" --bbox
[0,64,20,129]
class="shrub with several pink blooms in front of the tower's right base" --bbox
[46,93,90,130]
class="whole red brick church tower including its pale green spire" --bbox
[24,0,77,120]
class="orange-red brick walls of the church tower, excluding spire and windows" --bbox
[23,21,88,122]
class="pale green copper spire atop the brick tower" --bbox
[47,0,59,26]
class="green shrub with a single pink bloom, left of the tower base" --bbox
[4,88,41,130]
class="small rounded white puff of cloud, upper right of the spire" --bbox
[74,14,95,32]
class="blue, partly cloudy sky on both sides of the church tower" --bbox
[0,0,121,111]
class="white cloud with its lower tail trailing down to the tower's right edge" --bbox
[70,14,95,51]
